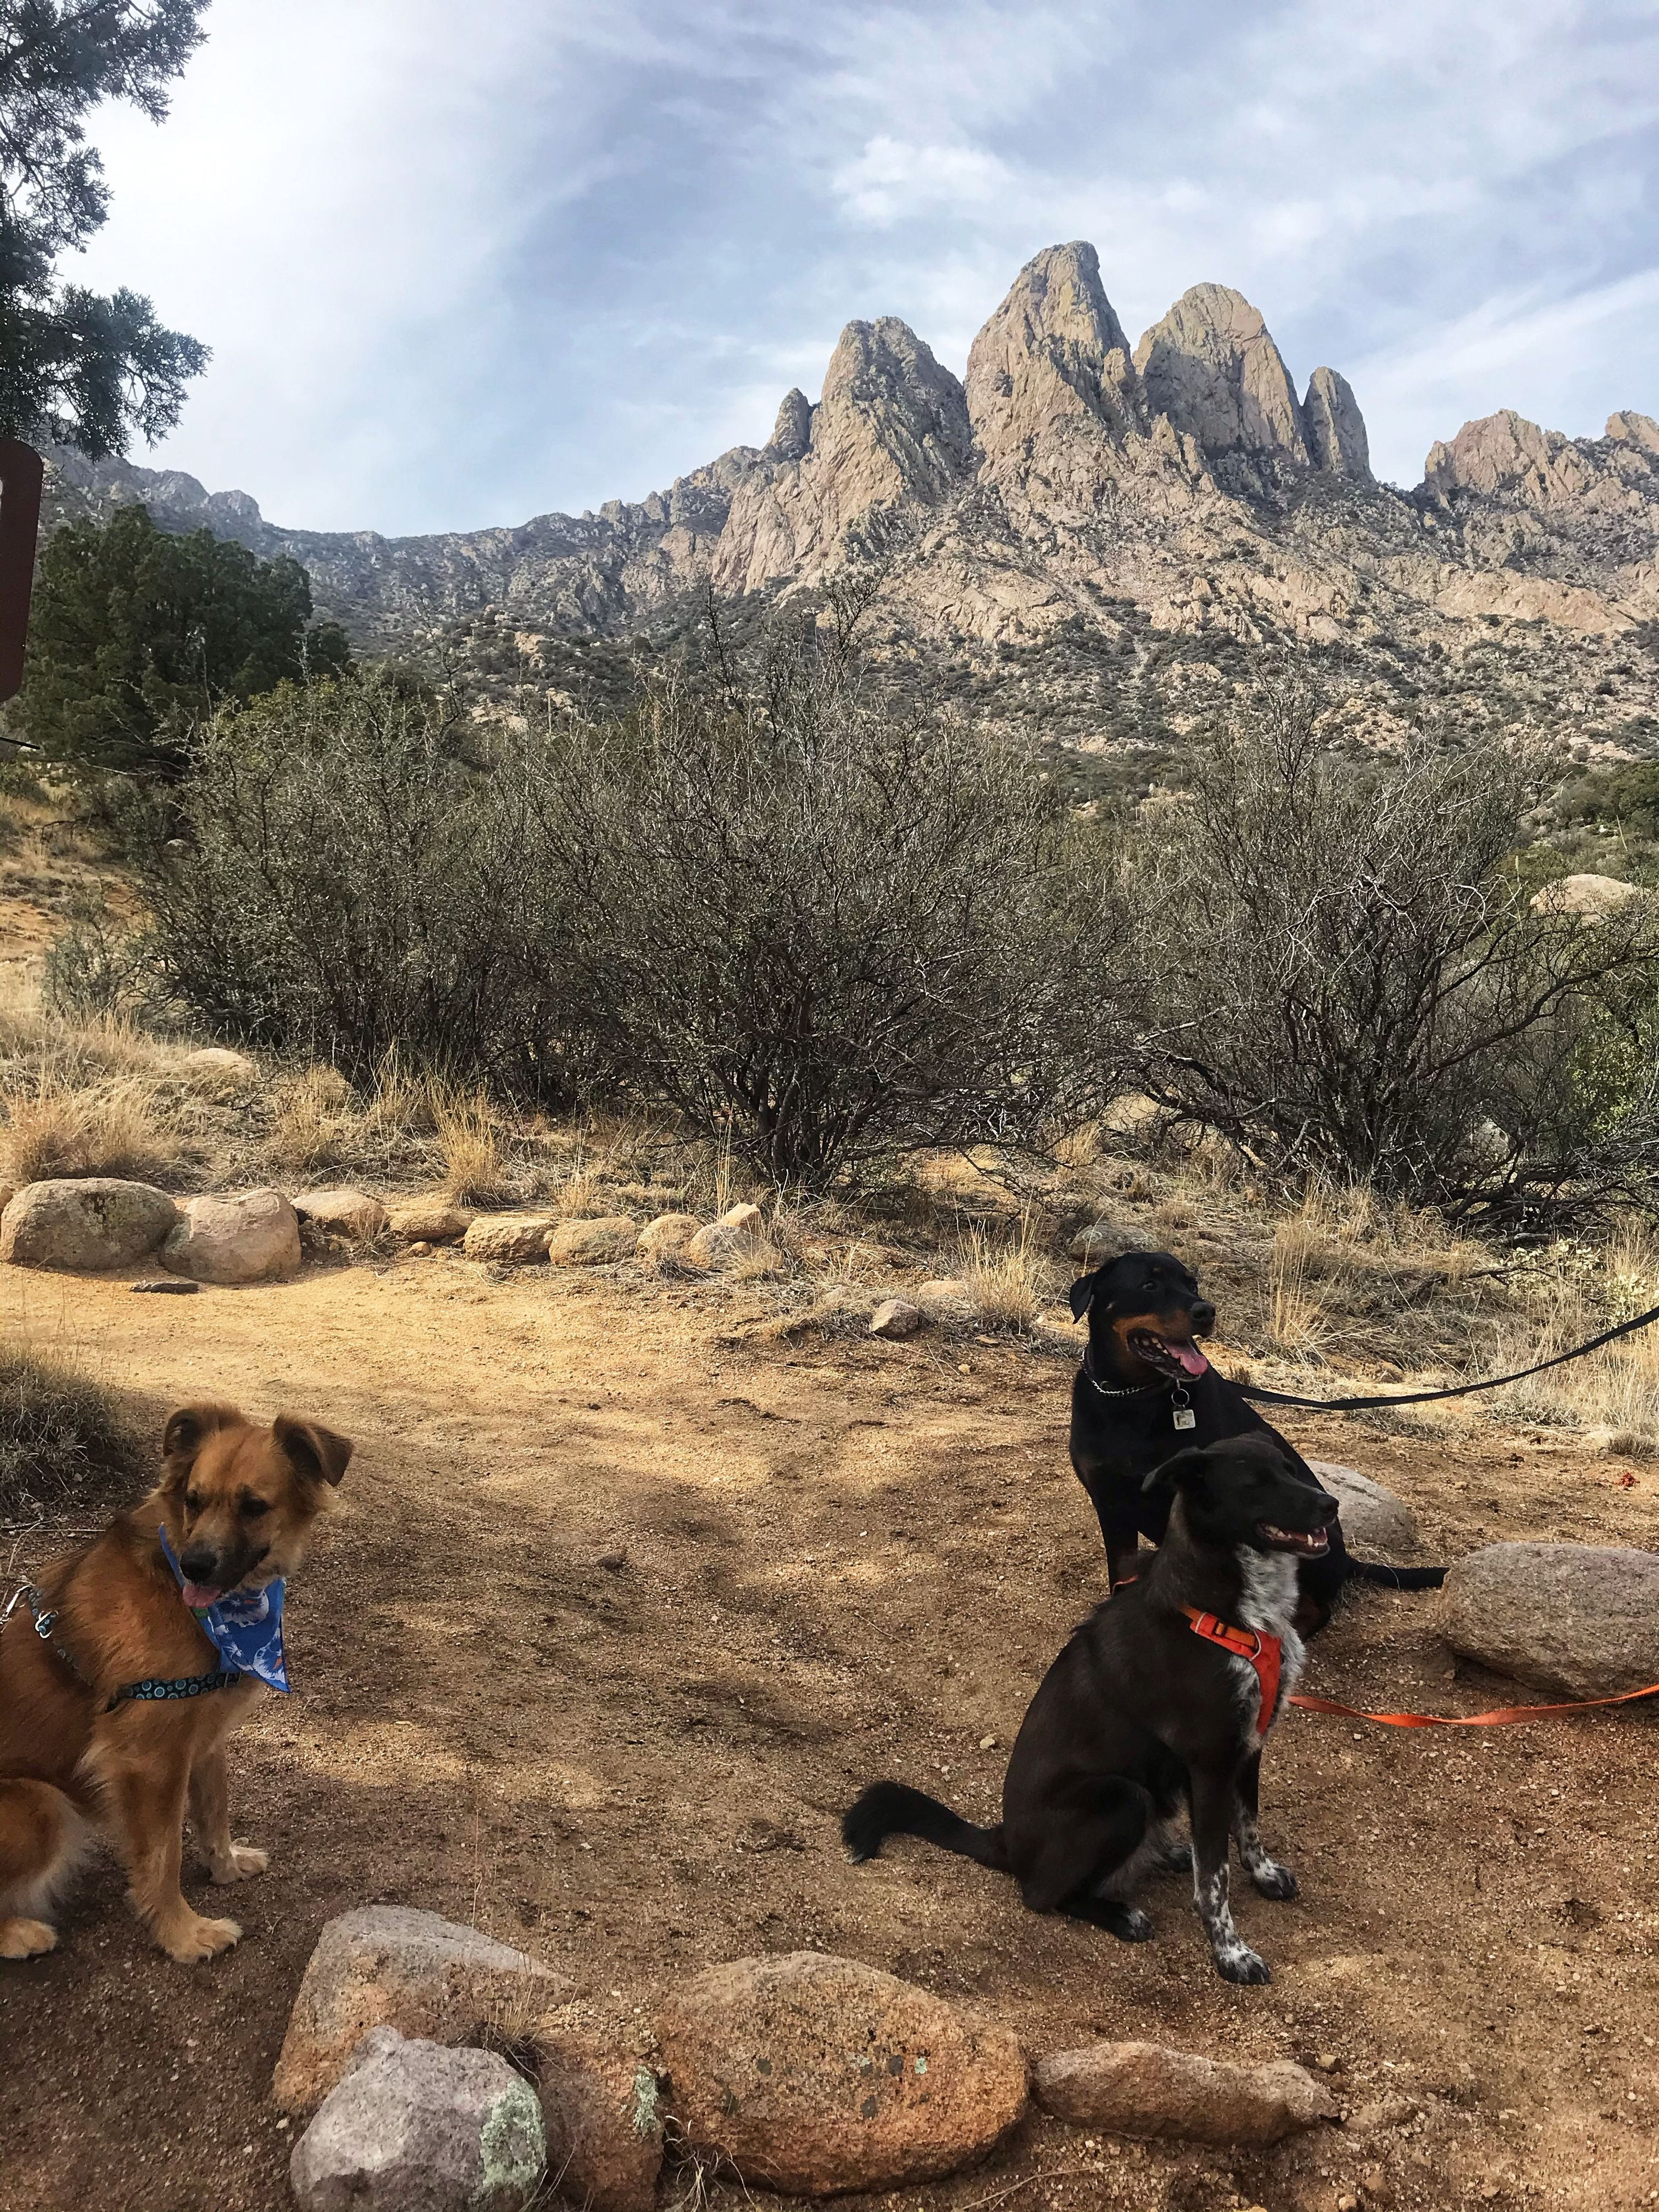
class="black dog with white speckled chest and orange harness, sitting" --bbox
[841,1436,1336,1982]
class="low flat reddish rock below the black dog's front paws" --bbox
[1033,2044,1336,2143]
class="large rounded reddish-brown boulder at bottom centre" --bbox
[659,1951,1027,2196]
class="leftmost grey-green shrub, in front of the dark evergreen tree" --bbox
[130,672,569,1095]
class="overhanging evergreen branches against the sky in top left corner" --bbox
[0,0,208,460]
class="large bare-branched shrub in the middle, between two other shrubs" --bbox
[542,624,1126,1188]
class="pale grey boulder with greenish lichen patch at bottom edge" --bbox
[288,2028,547,2212]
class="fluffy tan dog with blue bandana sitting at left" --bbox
[0,1405,352,1964]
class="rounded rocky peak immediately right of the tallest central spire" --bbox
[1135,283,1318,467]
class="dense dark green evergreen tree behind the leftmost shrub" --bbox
[11,506,352,776]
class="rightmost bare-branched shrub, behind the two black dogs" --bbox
[1137,668,1659,1212]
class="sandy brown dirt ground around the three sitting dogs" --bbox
[0,1256,1659,2212]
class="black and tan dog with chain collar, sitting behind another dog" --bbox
[1071,1252,1446,1635]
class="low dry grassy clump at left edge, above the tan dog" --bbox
[0,1345,144,1526]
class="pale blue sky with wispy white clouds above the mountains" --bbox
[71,0,1659,533]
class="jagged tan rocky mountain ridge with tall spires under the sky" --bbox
[39,241,1659,750]
